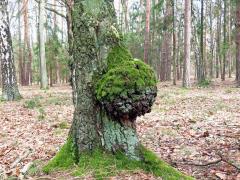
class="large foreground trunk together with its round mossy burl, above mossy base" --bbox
[70,0,157,160]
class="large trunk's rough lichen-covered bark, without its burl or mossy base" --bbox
[69,0,140,159]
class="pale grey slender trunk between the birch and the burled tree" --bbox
[39,0,48,89]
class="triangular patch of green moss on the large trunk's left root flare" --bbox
[43,138,76,173]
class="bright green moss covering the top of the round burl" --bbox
[96,46,157,101]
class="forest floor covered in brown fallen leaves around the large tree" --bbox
[0,80,240,180]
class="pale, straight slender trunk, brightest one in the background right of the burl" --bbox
[183,0,191,87]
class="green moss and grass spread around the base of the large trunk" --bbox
[43,140,193,180]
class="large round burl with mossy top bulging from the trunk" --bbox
[96,45,157,124]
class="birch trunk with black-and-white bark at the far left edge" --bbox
[0,0,21,101]
